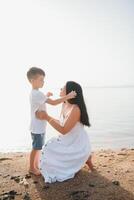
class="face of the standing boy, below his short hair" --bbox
[31,75,45,88]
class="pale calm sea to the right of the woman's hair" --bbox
[85,87,134,149]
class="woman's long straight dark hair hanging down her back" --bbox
[66,81,91,126]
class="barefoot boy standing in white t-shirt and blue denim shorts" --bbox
[27,67,76,175]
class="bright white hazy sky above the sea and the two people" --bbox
[0,0,134,150]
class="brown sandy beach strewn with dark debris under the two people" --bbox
[0,149,134,200]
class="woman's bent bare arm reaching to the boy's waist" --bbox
[36,106,80,135]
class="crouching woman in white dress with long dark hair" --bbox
[36,81,93,183]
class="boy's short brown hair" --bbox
[27,67,45,81]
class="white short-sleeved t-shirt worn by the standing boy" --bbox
[30,89,47,134]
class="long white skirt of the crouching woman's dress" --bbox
[40,108,91,183]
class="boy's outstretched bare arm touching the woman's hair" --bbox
[46,91,76,105]
